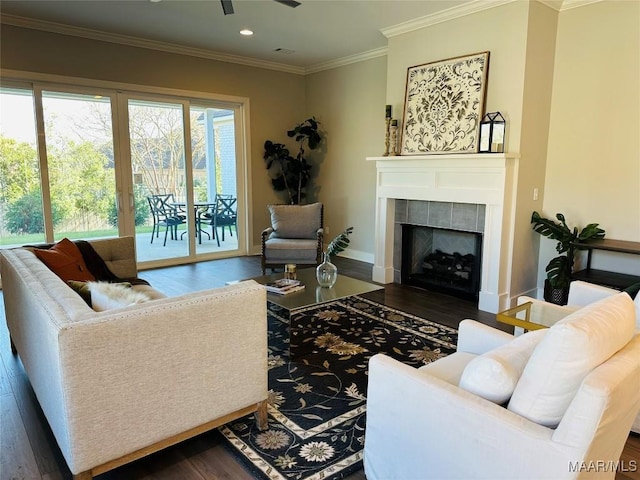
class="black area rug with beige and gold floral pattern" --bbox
[219,296,457,480]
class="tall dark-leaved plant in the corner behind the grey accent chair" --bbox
[263,117,322,205]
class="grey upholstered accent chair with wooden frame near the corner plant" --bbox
[262,203,324,275]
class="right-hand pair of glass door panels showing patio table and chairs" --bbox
[127,98,239,261]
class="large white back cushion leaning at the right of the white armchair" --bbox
[508,293,635,428]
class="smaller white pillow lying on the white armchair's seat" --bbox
[458,329,547,405]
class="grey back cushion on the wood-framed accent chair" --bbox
[269,203,322,239]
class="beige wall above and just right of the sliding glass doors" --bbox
[0,25,306,253]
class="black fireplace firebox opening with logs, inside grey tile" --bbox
[400,223,482,300]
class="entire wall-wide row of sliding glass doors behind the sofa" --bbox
[0,82,247,266]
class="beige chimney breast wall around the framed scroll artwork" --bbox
[387,2,544,296]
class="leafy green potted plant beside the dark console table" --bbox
[531,212,605,305]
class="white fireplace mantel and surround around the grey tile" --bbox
[367,153,518,313]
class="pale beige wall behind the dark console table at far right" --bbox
[539,0,640,281]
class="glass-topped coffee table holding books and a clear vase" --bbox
[252,268,384,358]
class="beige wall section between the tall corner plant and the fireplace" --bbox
[307,57,387,263]
